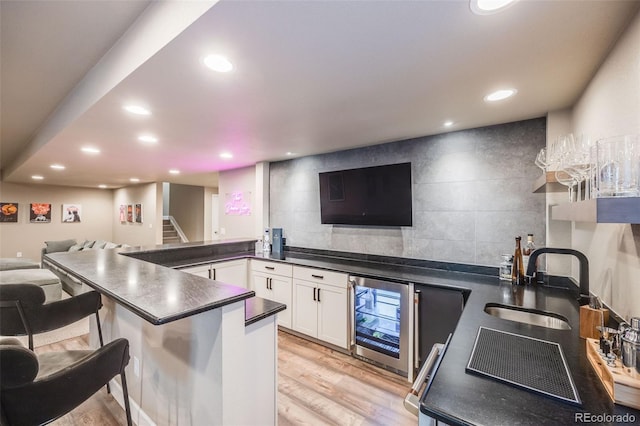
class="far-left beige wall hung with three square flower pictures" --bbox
[0,182,112,261]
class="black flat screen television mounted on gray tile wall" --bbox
[319,163,413,226]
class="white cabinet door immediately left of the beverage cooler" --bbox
[317,285,349,349]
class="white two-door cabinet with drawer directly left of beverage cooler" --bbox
[292,266,349,349]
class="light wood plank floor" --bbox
[36,332,418,426]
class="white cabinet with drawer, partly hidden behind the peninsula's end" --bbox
[250,260,292,328]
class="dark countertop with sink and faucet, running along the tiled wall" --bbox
[160,251,640,425]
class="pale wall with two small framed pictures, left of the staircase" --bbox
[110,183,162,246]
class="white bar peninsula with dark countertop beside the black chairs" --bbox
[44,241,285,425]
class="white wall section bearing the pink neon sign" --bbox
[218,166,262,238]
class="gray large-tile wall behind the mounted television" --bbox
[270,118,546,266]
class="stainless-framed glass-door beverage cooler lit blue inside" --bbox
[350,277,409,374]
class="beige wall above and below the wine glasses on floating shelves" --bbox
[571,13,640,320]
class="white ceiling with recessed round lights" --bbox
[0,0,640,188]
